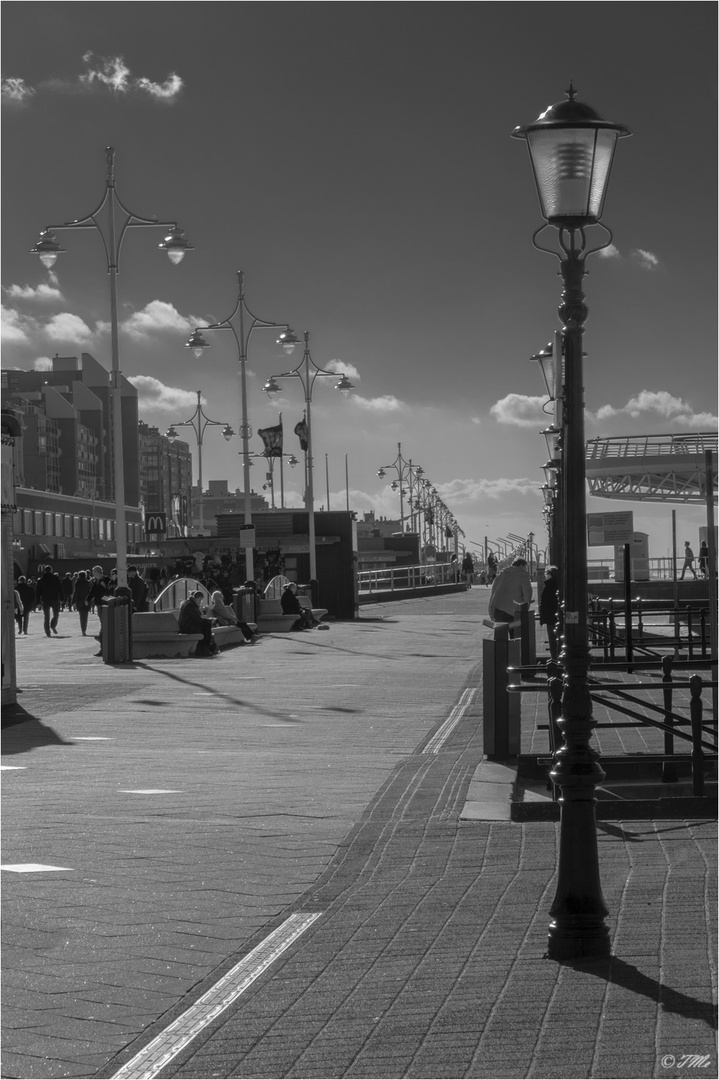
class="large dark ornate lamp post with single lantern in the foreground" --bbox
[512,84,630,960]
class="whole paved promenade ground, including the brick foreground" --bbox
[2,589,717,1080]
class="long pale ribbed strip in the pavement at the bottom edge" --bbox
[112,912,322,1080]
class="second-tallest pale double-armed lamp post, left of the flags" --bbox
[185,270,297,580]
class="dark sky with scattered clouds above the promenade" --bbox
[1,6,717,557]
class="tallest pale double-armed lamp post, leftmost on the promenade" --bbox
[31,146,192,585]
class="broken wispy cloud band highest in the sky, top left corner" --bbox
[2,52,185,106]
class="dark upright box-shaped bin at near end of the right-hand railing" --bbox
[483,622,521,760]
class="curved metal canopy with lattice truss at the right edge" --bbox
[586,431,717,503]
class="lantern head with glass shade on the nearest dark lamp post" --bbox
[512,85,632,225]
